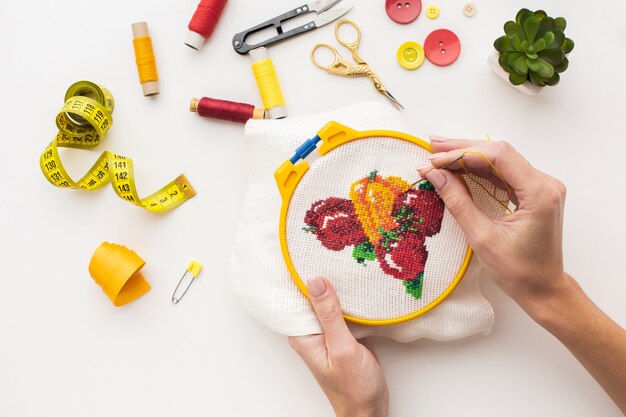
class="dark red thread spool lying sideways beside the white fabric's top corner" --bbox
[189,97,265,123]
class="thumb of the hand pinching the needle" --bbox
[426,169,494,247]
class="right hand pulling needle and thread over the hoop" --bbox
[418,136,568,313]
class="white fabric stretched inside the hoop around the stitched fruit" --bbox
[287,137,468,320]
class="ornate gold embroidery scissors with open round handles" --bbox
[311,19,404,109]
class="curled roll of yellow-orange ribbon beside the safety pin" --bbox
[89,242,150,307]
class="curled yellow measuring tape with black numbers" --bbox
[39,81,196,212]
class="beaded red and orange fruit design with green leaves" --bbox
[303,171,444,299]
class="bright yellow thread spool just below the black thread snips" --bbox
[249,47,287,119]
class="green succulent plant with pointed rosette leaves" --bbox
[493,9,574,87]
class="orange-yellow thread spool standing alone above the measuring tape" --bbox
[131,22,159,96]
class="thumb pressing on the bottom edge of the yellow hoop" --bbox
[307,278,356,351]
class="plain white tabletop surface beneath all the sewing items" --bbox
[0,0,626,417]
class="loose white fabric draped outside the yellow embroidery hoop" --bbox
[230,103,502,342]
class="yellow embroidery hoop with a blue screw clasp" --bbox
[274,122,473,326]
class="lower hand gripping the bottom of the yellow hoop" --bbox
[289,278,389,417]
